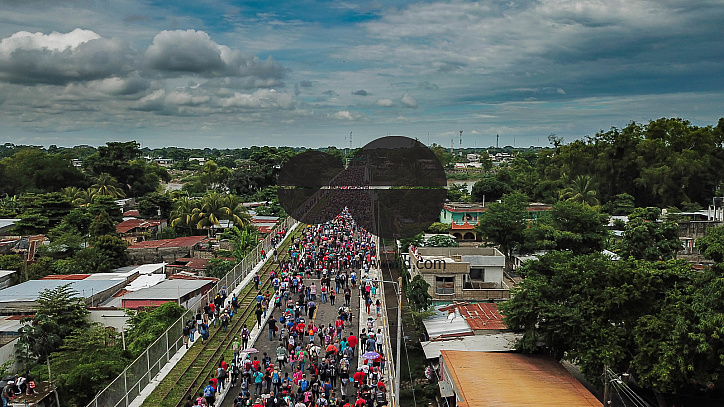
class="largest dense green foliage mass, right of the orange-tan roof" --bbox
[500,252,722,391]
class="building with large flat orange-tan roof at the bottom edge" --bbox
[439,350,603,407]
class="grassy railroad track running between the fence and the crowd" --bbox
[143,228,303,407]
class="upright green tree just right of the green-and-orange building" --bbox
[476,192,528,270]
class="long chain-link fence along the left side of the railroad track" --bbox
[87,217,296,407]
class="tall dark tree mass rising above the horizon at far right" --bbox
[538,118,724,208]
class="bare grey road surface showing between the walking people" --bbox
[217,273,360,407]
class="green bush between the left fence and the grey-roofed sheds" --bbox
[126,302,185,356]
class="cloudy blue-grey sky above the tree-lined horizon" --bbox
[0,0,724,148]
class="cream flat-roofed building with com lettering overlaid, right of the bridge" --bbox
[410,246,510,301]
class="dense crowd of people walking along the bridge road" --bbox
[187,209,387,407]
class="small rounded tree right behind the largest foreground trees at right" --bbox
[619,207,681,260]
